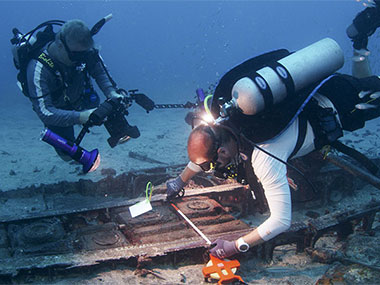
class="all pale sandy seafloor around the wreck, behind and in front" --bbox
[0,99,380,284]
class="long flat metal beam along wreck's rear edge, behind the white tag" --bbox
[0,164,248,223]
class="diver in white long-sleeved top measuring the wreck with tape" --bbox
[167,3,380,258]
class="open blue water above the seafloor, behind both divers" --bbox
[0,0,377,108]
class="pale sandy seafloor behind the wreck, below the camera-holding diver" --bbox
[0,100,191,191]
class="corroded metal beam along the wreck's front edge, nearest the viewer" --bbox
[0,197,380,275]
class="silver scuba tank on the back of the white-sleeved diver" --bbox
[220,38,344,117]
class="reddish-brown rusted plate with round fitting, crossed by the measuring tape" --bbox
[110,197,249,244]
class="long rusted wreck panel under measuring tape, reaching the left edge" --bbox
[0,197,251,275]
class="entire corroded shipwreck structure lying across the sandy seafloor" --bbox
[0,152,380,278]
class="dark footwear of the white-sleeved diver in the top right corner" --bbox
[346,1,380,50]
